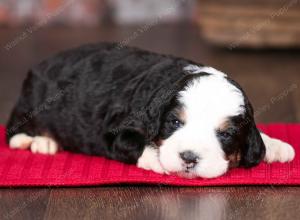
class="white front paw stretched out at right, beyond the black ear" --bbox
[261,133,295,163]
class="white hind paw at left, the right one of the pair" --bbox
[31,136,58,155]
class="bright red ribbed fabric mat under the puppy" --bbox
[0,124,300,187]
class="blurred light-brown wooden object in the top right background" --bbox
[197,0,300,49]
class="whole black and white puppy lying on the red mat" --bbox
[7,43,295,178]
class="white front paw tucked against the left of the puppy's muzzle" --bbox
[137,145,167,174]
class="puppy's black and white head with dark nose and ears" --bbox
[156,65,265,178]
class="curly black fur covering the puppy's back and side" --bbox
[7,43,260,167]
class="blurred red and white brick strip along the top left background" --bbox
[0,0,195,26]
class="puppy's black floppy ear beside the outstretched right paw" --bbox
[240,120,266,168]
